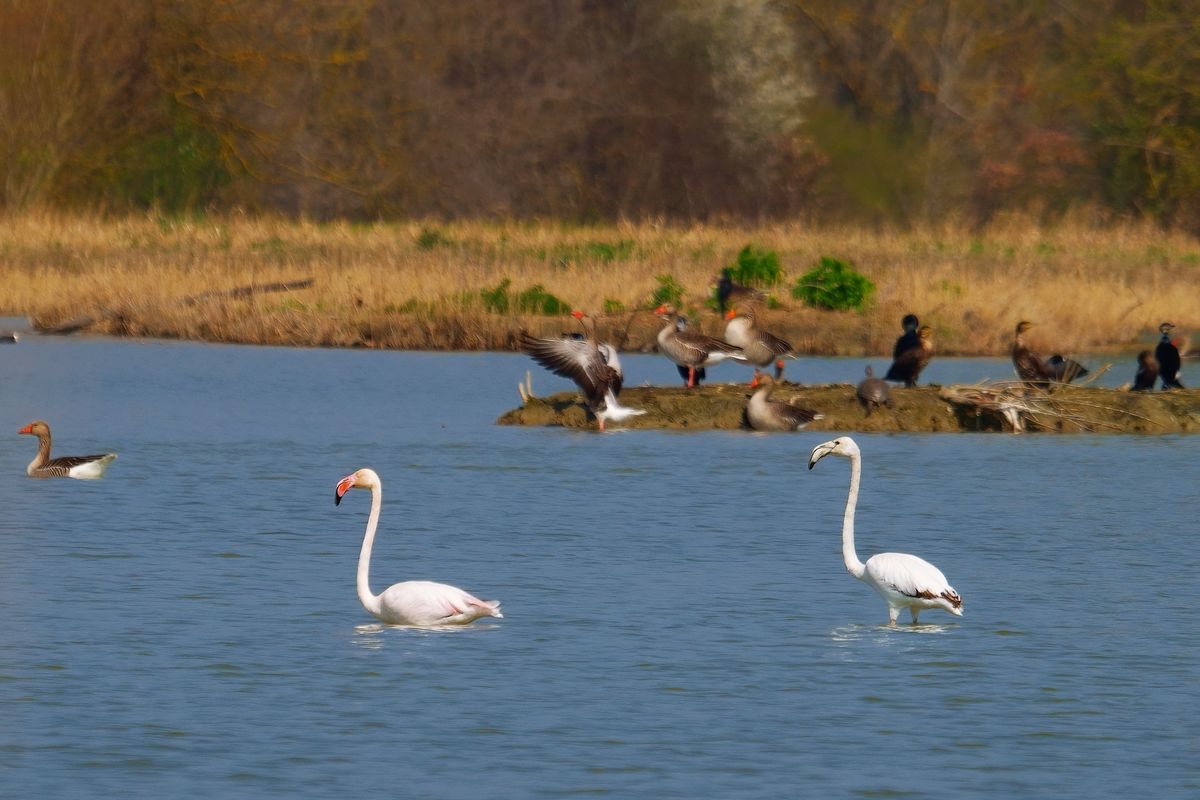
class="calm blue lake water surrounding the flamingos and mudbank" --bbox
[0,328,1200,799]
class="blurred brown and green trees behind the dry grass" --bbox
[7,0,1200,233]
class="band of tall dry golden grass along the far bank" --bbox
[0,213,1200,355]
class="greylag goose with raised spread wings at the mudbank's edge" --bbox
[520,311,646,431]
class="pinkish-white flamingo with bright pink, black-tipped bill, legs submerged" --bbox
[334,469,504,626]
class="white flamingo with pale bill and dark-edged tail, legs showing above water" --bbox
[809,437,962,625]
